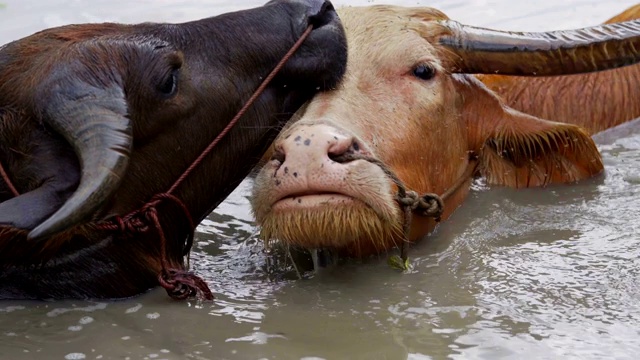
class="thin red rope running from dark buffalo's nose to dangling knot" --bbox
[0,25,313,300]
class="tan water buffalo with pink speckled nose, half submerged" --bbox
[252,6,640,256]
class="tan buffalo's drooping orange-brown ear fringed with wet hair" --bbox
[460,75,603,188]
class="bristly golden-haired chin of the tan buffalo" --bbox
[260,200,402,257]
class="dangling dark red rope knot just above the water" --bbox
[158,269,213,300]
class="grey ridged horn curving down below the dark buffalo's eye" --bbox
[28,84,133,239]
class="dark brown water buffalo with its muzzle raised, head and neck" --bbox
[0,0,346,298]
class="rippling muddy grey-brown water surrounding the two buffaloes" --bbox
[0,0,640,359]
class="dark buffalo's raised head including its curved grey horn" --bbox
[0,0,346,248]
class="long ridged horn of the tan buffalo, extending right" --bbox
[440,20,640,76]
